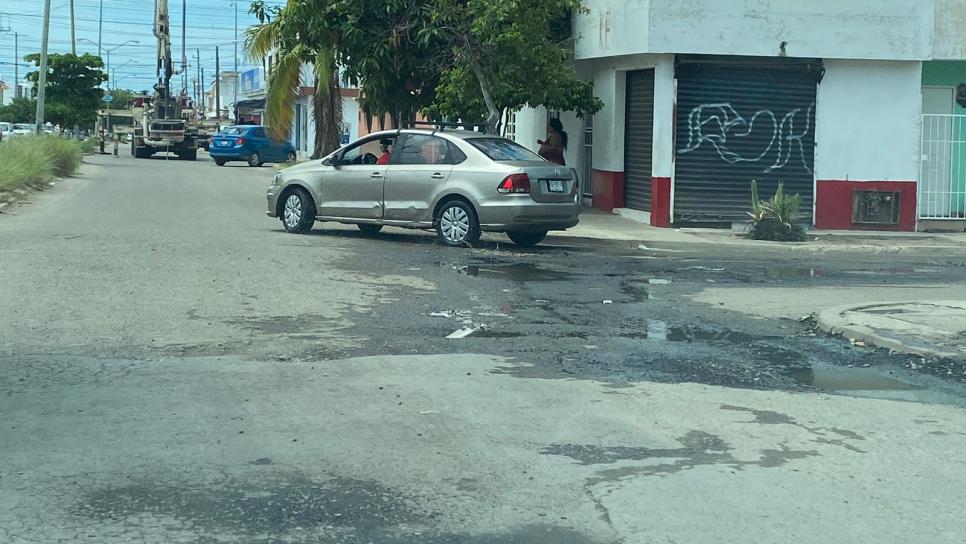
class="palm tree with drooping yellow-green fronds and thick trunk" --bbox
[247,0,342,157]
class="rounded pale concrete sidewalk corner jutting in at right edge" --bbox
[818,300,966,361]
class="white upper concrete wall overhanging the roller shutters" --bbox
[574,0,966,60]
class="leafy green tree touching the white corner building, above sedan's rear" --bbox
[420,0,601,126]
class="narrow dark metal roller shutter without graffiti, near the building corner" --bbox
[624,70,654,211]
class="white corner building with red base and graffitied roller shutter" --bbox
[513,0,966,230]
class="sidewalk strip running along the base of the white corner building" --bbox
[550,208,966,251]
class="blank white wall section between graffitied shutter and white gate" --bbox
[815,60,922,181]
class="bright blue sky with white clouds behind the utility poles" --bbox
[0,0,284,90]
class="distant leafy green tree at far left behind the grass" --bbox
[24,53,107,129]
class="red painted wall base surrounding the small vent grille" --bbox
[815,180,916,231]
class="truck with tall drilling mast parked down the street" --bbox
[131,0,198,161]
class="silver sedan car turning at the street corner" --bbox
[268,129,580,246]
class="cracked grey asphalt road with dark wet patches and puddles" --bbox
[0,157,966,544]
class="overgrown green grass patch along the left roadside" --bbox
[0,136,81,191]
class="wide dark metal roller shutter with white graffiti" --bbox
[674,57,823,222]
